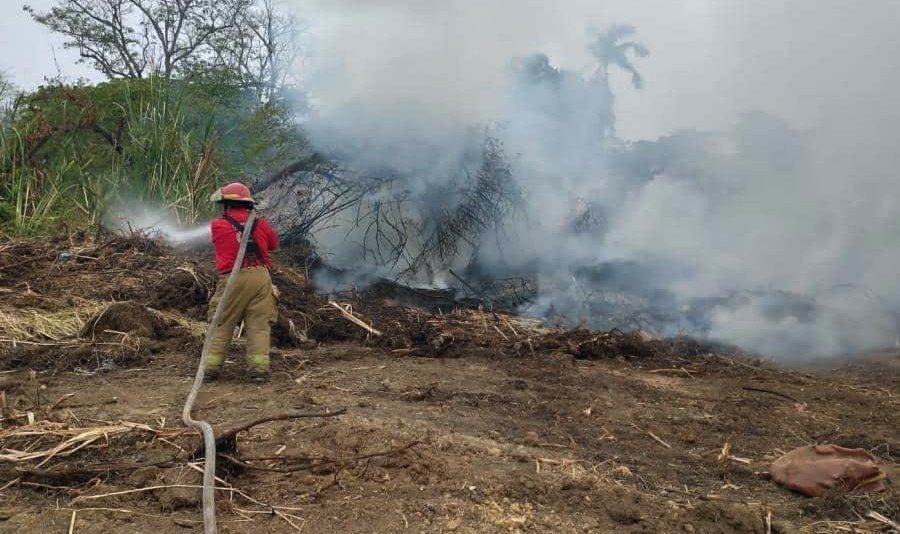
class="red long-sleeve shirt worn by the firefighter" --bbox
[209,208,278,274]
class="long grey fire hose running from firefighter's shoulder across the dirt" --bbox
[181,211,256,534]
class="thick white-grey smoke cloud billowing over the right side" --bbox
[284,0,900,355]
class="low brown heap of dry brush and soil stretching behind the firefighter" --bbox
[0,229,732,370]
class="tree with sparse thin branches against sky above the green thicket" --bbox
[24,0,299,98]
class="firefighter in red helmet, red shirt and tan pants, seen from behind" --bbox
[206,182,278,382]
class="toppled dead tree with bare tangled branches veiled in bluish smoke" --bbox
[254,136,522,278]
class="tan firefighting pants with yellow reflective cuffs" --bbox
[206,267,277,371]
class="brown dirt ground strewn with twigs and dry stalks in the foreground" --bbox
[0,236,900,534]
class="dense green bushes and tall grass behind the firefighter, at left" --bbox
[0,78,303,233]
